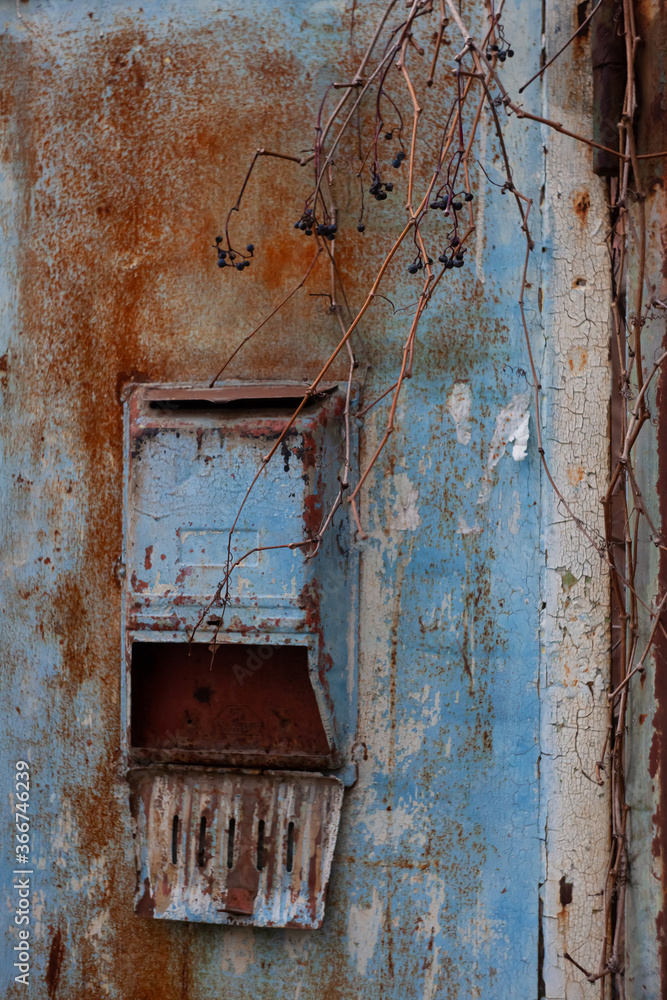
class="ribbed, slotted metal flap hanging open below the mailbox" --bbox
[128,765,343,930]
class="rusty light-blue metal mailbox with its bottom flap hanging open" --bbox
[122,382,357,928]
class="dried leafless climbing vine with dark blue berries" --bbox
[196,0,667,997]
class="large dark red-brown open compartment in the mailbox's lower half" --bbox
[130,641,332,768]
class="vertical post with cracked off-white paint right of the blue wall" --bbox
[544,0,610,1000]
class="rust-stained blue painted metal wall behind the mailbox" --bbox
[0,0,608,1000]
